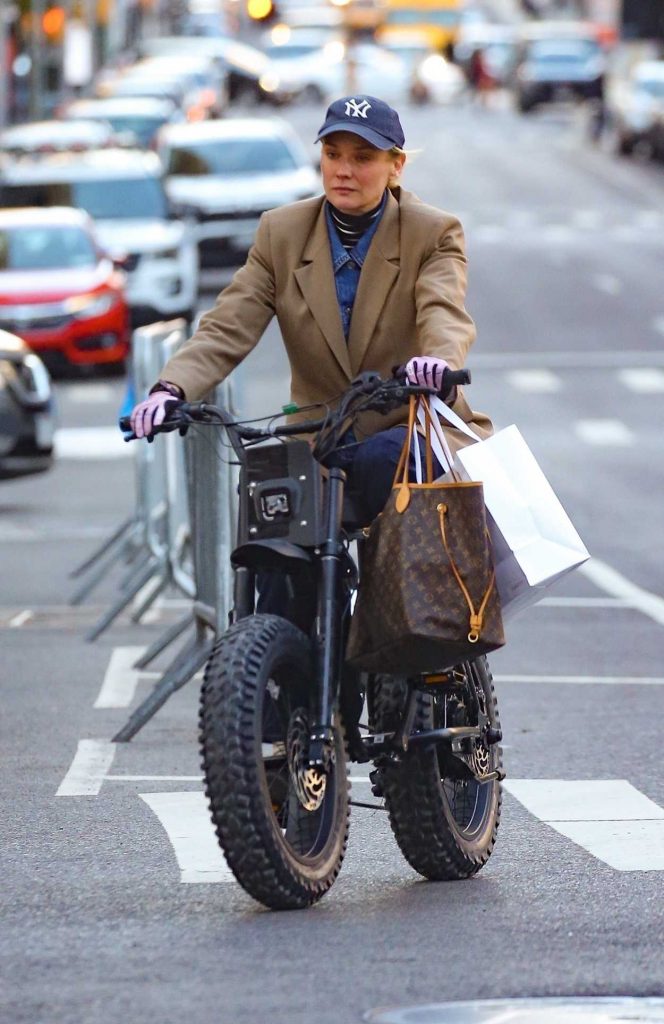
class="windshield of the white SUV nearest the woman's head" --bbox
[167,138,297,175]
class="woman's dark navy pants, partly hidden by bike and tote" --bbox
[256,427,442,633]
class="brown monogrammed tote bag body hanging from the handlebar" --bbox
[346,483,505,675]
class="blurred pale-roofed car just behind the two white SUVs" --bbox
[60,96,183,150]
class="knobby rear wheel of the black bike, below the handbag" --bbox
[370,657,502,881]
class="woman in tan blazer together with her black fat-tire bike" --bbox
[131,95,502,908]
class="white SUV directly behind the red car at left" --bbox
[0,150,198,325]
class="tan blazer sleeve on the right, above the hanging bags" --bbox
[415,217,475,370]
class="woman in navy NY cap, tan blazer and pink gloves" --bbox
[131,95,492,528]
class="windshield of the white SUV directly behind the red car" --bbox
[0,177,168,220]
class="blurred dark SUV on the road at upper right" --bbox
[514,36,606,114]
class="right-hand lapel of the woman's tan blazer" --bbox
[348,193,401,375]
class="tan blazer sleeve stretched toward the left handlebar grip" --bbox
[159,214,275,401]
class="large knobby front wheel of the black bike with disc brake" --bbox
[200,614,349,909]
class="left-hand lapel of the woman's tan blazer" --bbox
[294,204,352,380]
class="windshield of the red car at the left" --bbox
[0,224,97,270]
